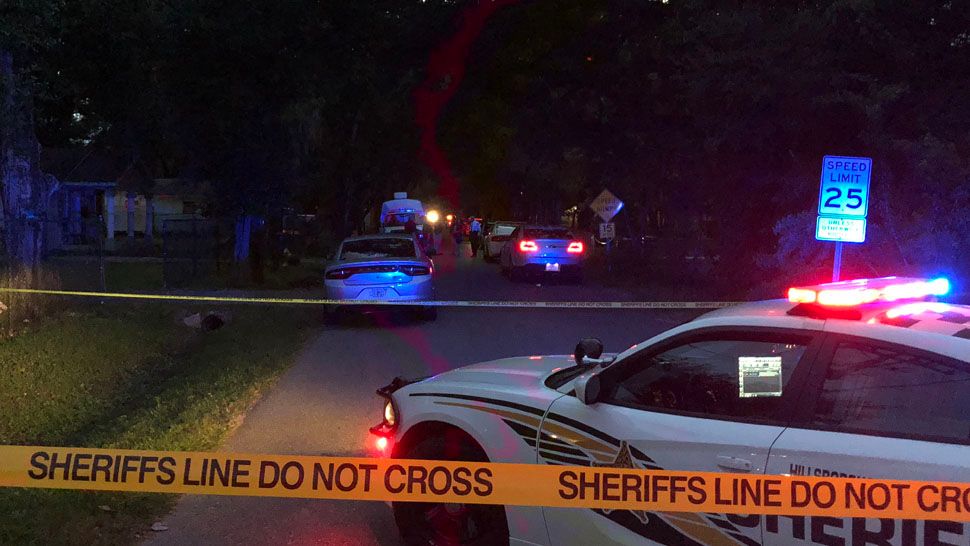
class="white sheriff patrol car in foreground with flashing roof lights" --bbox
[371,277,970,546]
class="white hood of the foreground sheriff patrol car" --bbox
[427,355,573,388]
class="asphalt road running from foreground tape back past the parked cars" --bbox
[149,240,696,545]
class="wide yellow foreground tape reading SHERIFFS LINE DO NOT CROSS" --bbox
[0,446,970,522]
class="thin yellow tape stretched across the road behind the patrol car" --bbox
[0,287,741,309]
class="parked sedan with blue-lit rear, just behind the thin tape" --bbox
[324,234,437,320]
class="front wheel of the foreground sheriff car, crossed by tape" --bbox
[393,434,509,546]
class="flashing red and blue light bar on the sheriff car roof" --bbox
[788,277,950,307]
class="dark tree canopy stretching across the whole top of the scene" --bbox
[0,0,970,286]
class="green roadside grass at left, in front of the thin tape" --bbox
[0,304,311,544]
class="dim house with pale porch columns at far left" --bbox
[41,147,203,250]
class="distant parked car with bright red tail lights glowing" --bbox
[499,226,586,280]
